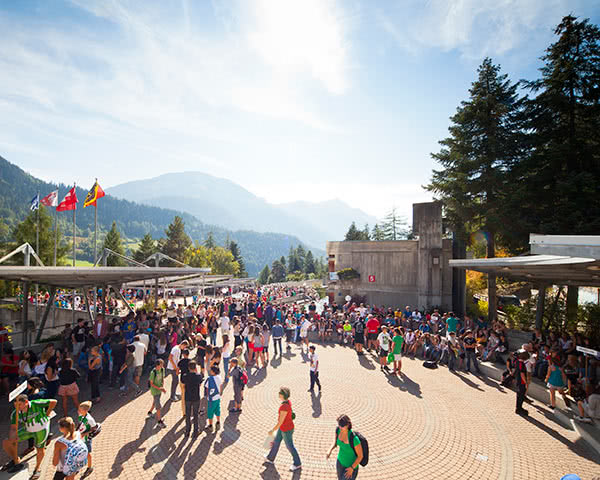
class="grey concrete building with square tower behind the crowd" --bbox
[327,202,452,310]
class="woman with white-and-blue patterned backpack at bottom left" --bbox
[52,417,88,480]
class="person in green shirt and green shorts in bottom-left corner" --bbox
[2,394,57,480]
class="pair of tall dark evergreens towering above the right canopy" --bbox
[425,15,600,324]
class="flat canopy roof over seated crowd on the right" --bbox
[450,255,600,287]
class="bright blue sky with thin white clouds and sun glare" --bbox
[0,0,600,218]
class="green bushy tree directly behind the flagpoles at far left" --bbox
[13,205,71,266]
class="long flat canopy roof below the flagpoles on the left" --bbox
[0,266,211,288]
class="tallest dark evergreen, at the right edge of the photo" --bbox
[510,15,600,323]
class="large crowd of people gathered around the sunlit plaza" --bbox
[2,285,600,480]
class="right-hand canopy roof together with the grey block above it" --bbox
[450,234,600,287]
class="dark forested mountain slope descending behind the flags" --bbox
[0,156,325,276]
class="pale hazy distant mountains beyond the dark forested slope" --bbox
[106,172,375,249]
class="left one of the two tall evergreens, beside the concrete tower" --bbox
[427,58,522,320]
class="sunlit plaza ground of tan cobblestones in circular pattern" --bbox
[2,345,600,480]
